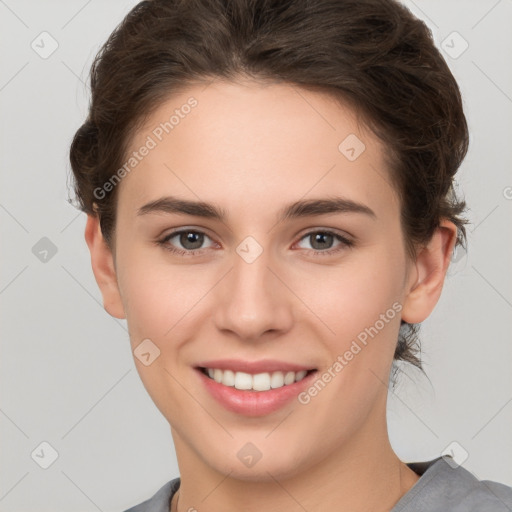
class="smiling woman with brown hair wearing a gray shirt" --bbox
[70,0,512,512]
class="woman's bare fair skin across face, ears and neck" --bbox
[85,81,456,512]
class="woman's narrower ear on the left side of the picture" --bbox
[85,215,126,318]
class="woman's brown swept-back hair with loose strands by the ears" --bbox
[70,0,469,371]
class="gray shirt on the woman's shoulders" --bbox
[125,457,512,512]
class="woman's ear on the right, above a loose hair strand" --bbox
[402,219,457,324]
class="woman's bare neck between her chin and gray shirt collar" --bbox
[172,396,419,512]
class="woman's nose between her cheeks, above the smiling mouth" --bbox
[214,241,293,342]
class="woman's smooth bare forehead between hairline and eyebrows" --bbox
[120,81,398,222]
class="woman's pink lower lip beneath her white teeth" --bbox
[196,368,317,416]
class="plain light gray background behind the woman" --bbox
[0,0,512,512]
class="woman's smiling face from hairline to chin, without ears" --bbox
[86,82,446,480]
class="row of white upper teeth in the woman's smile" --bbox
[202,368,308,391]
